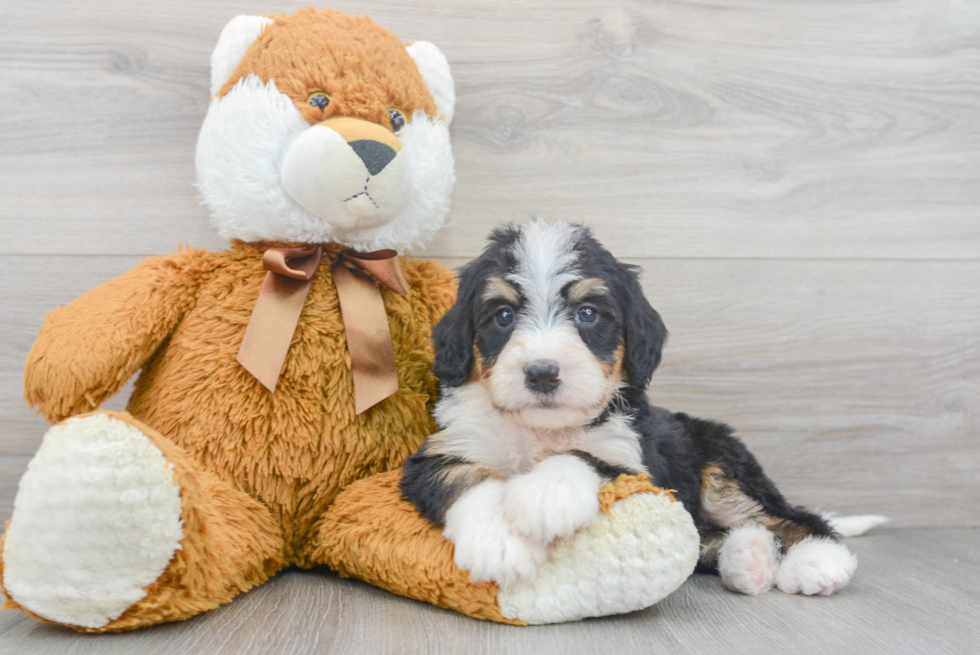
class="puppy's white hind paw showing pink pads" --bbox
[718,525,778,596]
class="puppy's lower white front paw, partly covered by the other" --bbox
[442,480,548,587]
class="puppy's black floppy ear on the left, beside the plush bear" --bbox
[432,262,482,387]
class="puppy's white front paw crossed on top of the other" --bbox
[504,455,603,544]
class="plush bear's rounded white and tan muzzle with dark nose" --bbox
[281,118,412,231]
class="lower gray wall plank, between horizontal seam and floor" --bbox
[0,256,980,527]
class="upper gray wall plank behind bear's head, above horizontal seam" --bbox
[0,0,980,260]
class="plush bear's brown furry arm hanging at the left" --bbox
[24,250,218,422]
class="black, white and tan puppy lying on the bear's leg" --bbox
[402,220,857,594]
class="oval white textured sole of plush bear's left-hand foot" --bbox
[3,414,184,628]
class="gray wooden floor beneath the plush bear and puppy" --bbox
[0,529,980,655]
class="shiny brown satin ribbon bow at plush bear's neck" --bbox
[238,245,408,414]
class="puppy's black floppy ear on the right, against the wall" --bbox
[618,264,667,389]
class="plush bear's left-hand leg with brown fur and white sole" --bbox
[0,412,282,632]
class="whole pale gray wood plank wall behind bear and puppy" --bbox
[0,0,980,527]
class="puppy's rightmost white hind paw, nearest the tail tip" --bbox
[776,537,857,596]
